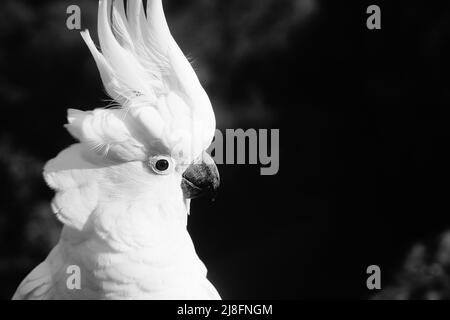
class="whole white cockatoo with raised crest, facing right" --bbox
[13,0,220,299]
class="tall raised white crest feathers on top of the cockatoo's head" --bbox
[72,0,215,161]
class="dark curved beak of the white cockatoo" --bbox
[181,152,220,199]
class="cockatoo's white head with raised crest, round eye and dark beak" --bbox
[44,0,219,235]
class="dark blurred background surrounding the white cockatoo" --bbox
[0,0,450,299]
